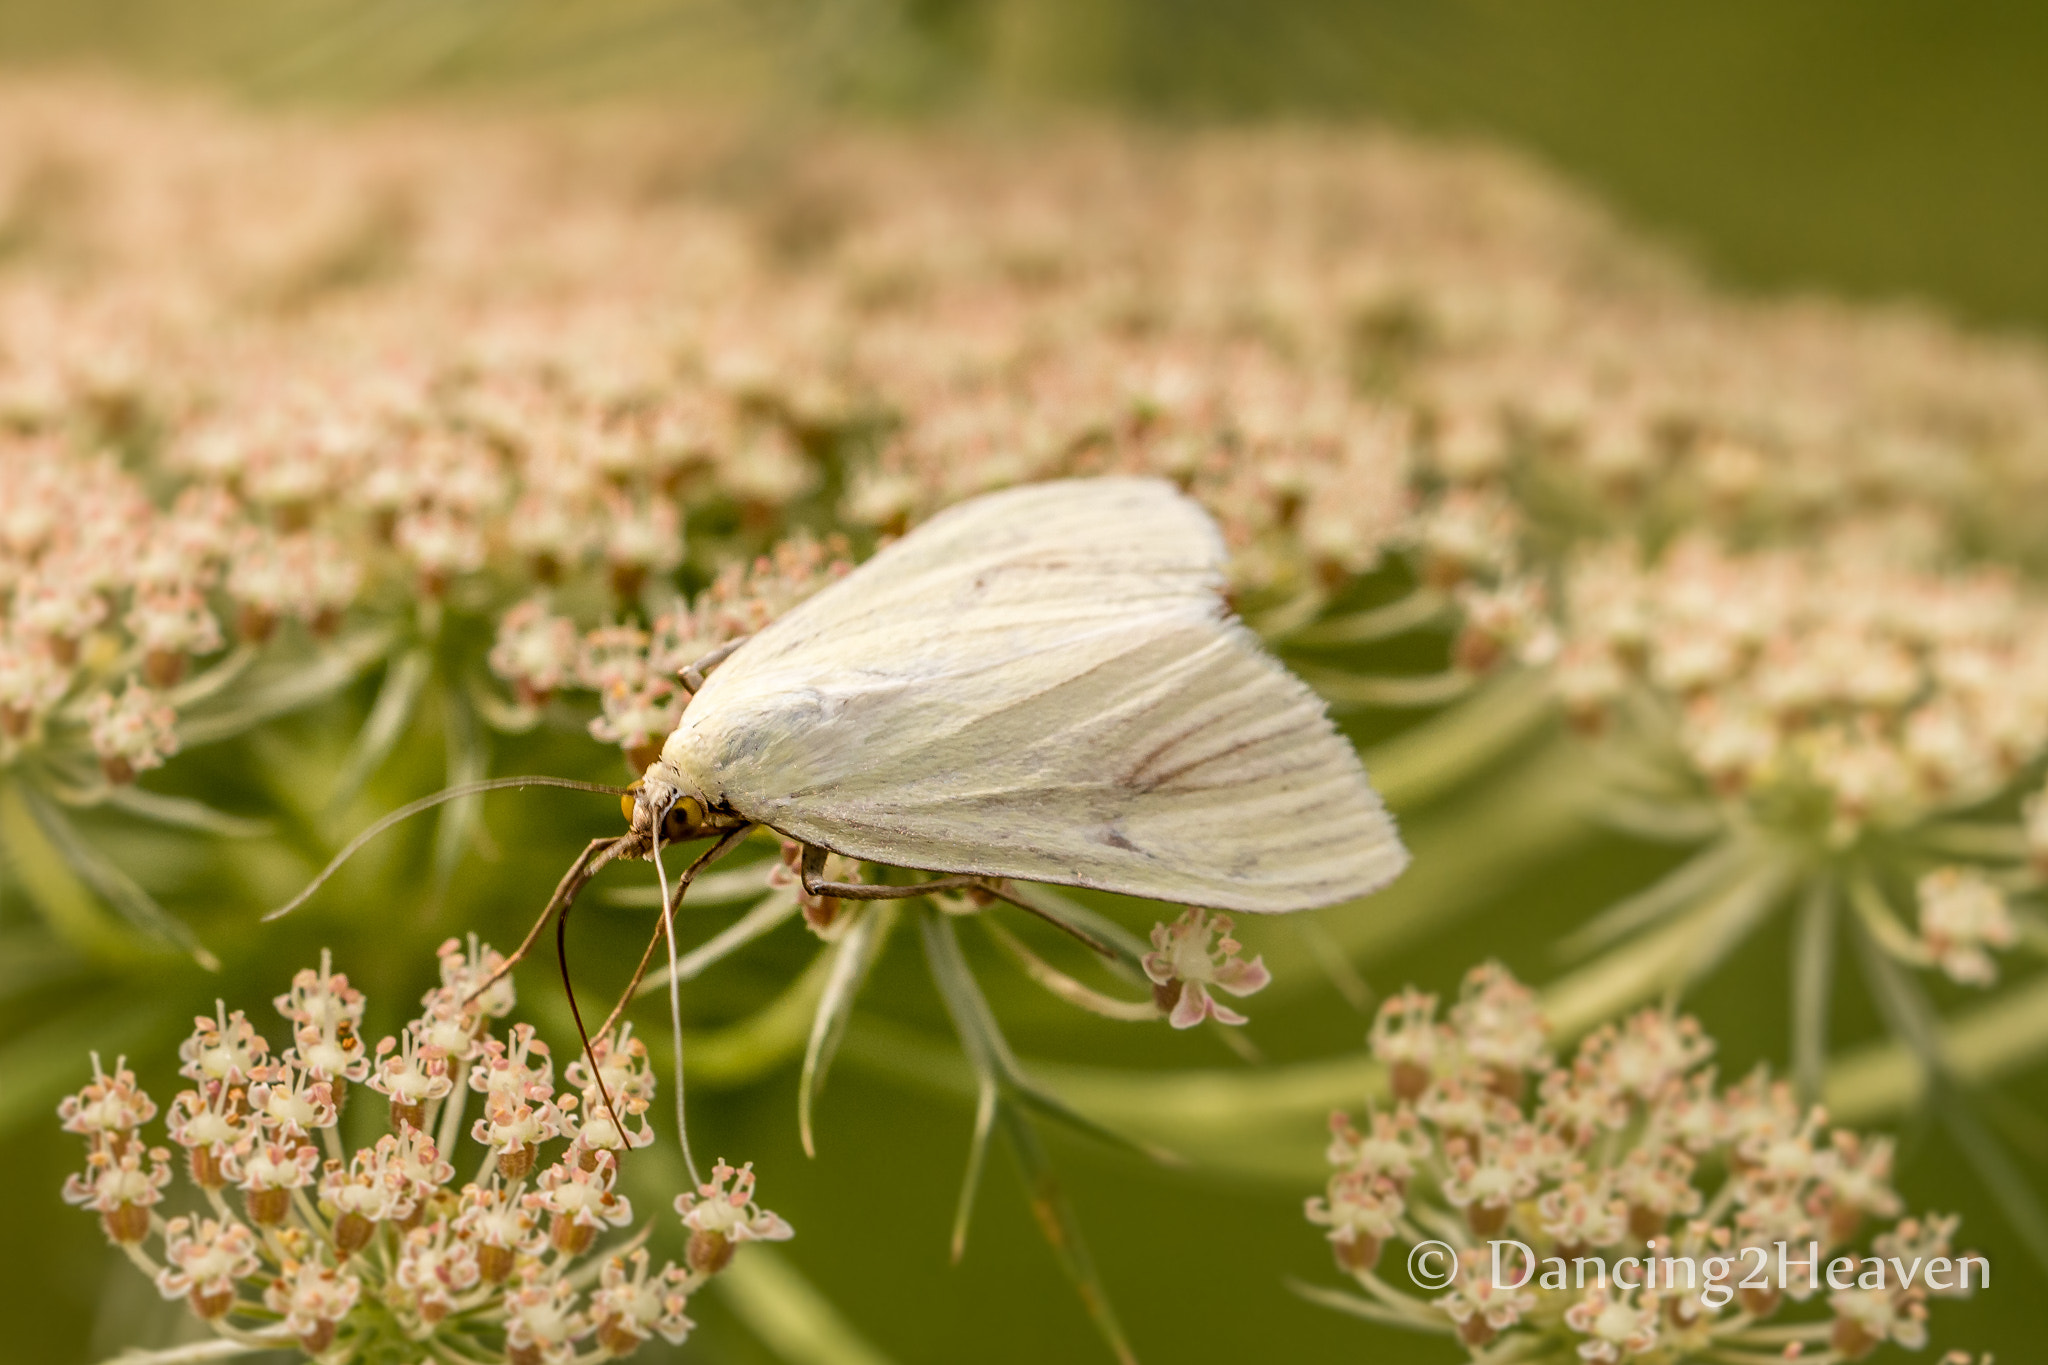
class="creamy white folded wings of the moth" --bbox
[664,479,1407,911]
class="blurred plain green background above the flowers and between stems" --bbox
[0,0,2048,1361]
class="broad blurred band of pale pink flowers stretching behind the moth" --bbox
[12,84,2048,796]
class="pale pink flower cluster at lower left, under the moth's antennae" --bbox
[59,939,791,1365]
